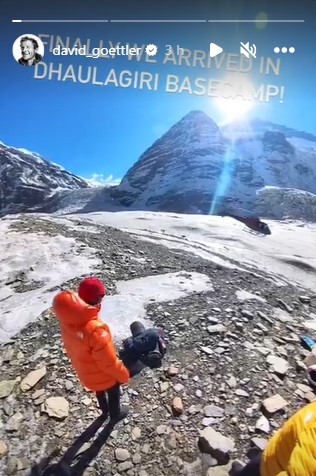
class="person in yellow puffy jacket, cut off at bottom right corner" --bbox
[231,402,316,476]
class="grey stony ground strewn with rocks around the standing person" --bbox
[0,216,316,476]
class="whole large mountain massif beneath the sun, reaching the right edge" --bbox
[113,111,316,213]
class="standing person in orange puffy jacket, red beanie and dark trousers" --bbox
[53,277,130,419]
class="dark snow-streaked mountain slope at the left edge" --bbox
[0,143,89,215]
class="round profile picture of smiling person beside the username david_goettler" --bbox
[12,33,44,66]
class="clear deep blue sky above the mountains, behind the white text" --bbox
[0,0,316,182]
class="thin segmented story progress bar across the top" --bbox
[12,20,305,23]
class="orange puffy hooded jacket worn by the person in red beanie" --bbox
[53,291,129,392]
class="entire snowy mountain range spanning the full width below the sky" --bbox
[0,111,316,220]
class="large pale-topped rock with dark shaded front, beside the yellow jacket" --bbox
[198,427,235,464]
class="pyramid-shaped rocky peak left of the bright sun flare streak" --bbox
[114,111,230,212]
